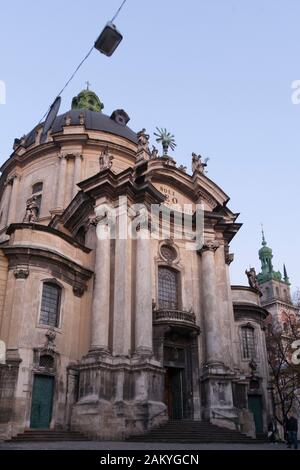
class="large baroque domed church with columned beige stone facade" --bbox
[0,90,272,439]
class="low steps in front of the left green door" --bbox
[8,429,89,442]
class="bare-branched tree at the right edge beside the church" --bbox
[266,313,300,426]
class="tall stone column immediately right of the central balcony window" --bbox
[201,241,224,365]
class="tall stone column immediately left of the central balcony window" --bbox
[135,227,153,355]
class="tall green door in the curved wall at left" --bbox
[30,375,54,429]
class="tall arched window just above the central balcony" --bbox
[158,267,178,310]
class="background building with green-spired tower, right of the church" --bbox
[257,232,300,437]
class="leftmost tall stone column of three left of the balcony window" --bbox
[90,217,110,352]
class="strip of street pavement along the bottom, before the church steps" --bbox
[0,441,296,451]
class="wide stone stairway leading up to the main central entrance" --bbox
[127,420,265,444]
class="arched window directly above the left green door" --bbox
[40,282,61,327]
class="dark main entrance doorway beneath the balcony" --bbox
[165,367,183,419]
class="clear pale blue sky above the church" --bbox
[0,0,300,290]
